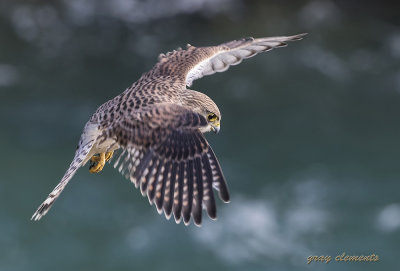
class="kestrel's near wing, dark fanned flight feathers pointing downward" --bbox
[104,104,229,225]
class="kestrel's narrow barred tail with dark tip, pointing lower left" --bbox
[31,140,94,221]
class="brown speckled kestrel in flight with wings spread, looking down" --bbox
[32,34,305,225]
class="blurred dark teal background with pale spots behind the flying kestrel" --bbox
[0,0,400,271]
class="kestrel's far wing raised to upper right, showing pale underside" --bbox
[151,34,306,87]
